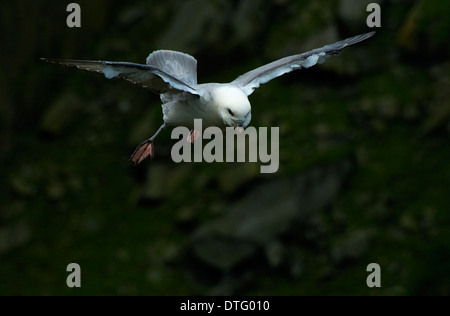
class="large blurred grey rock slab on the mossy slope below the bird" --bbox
[192,161,351,270]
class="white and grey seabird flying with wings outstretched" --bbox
[41,32,375,164]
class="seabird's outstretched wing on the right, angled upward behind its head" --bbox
[231,32,375,95]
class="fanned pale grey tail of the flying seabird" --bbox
[147,50,197,85]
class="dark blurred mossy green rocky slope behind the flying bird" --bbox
[0,0,450,295]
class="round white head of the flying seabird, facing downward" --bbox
[212,85,252,128]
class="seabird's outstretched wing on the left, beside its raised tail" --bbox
[41,58,199,95]
